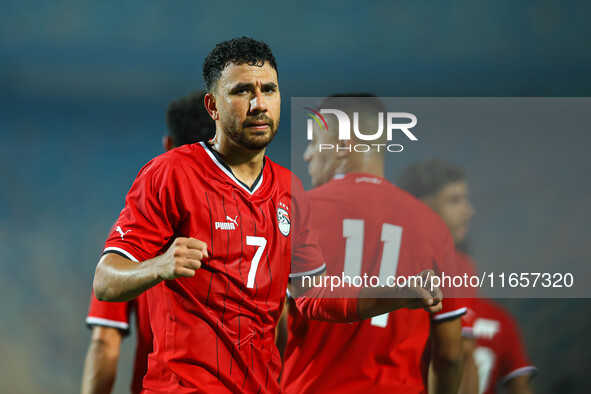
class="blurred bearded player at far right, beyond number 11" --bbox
[398,159,535,394]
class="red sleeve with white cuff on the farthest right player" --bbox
[498,310,536,382]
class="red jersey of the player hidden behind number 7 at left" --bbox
[86,293,152,394]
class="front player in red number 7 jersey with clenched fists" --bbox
[94,37,441,393]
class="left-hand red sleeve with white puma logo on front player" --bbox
[104,155,183,262]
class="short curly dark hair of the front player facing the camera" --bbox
[203,37,277,92]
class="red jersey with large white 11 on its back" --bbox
[281,174,466,394]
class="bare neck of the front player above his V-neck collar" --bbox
[210,136,265,187]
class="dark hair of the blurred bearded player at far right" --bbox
[396,159,466,199]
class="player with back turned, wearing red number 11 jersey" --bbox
[281,95,466,393]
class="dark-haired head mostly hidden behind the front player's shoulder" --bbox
[166,91,215,146]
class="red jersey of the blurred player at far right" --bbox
[463,298,536,394]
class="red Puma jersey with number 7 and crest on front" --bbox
[105,143,325,393]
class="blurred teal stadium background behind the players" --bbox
[0,0,591,393]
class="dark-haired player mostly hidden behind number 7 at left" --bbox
[81,91,215,394]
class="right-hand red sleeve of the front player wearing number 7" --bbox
[289,176,326,279]
